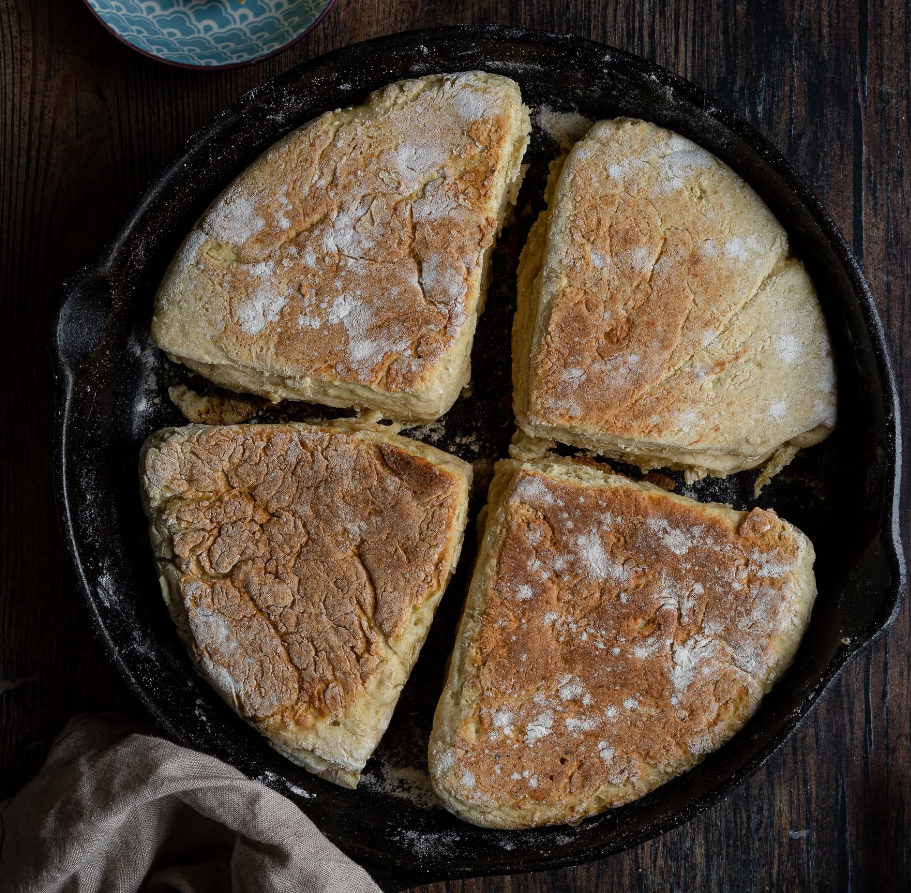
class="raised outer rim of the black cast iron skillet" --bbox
[50,25,907,889]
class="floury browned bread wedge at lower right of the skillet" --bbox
[429,457,816,828]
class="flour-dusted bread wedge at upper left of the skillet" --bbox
[152,72,530,421]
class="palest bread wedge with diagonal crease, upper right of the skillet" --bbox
[513,119,835,479]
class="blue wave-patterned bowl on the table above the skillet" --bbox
[88,0,331,66]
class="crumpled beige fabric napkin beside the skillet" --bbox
[0,716,379,893]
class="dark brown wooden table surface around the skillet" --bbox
[0,0,911,893]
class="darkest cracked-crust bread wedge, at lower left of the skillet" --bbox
[140,421,471,787]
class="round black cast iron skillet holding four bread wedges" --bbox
[54,27,904,890]
